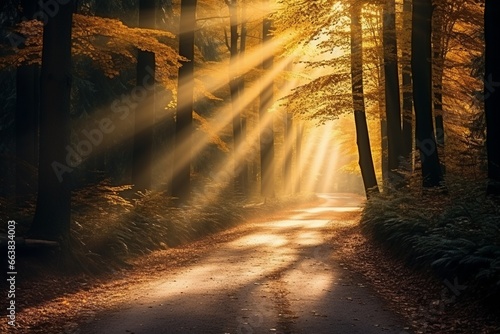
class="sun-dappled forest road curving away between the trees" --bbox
[77,194,409,334]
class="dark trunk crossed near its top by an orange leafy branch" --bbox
[132,0,156,190]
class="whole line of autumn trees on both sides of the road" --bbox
[0,0,500,245]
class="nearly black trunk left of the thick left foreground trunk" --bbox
[15,0,40,205]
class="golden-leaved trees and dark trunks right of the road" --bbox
[276,0,499,195]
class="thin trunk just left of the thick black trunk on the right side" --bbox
[401,0,413,166]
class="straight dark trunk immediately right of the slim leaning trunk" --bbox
[383,0,401,181]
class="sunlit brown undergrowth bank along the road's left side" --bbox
[2,182,315,275]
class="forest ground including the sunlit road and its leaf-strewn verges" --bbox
[0,194,500,334]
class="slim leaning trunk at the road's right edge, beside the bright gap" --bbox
[351,6,379,197]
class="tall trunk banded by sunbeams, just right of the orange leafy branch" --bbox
[172,0,197,203]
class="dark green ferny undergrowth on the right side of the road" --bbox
[361,180,500,305]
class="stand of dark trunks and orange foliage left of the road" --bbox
[2,0,301,240]
